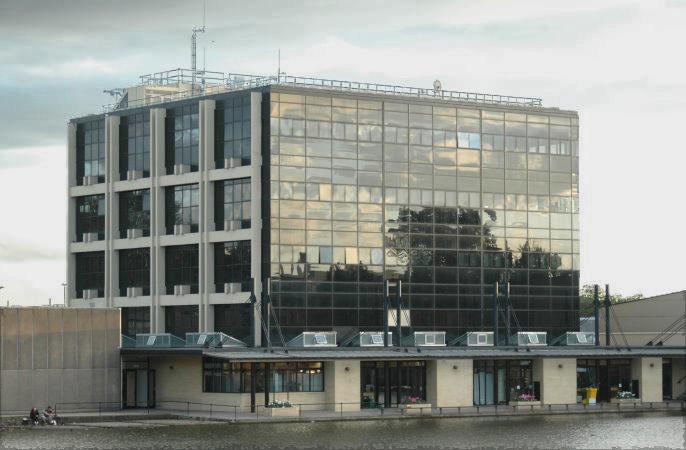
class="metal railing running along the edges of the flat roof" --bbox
[103,69,543,112]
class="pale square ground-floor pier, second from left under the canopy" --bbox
[426,359,474,408]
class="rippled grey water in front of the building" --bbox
[0,413,686,449]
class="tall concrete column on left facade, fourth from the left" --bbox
[198,100,215,331]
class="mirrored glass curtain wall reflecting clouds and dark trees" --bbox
[269,93,579,338]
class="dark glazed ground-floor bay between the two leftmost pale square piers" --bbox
[360,361,426,408]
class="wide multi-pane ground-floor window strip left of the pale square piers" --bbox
[203,358,324,393]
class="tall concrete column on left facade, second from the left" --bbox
[105,116,121,307]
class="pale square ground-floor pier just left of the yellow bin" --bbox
[534,358,576,405]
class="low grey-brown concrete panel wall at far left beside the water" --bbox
[0,307,121,415]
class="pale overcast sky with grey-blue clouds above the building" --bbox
[0,0,686,305]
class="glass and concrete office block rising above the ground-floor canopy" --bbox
[68,69,579,344]
